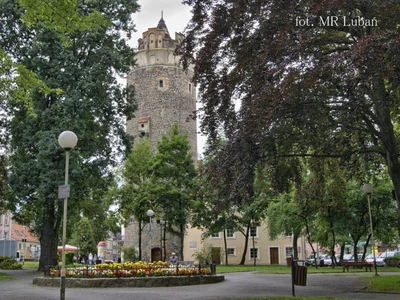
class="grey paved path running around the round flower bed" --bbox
[0,270,400,300]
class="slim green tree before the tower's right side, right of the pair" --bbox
[153,124,196,260]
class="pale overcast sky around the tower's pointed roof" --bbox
[130,0,205,155]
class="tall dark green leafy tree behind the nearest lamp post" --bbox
[0,0,138,269]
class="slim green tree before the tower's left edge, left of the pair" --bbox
[119,138,154,260]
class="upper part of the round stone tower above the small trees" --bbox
[127,17,197,162]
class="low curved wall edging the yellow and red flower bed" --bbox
[33,275,225,288]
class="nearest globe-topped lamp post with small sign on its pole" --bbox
[58,131,78,300]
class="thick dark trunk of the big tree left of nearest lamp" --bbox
[38,199,59,271]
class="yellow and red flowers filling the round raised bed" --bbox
[50,261,211,278]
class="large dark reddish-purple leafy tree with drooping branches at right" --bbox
[183,0,400,237]
